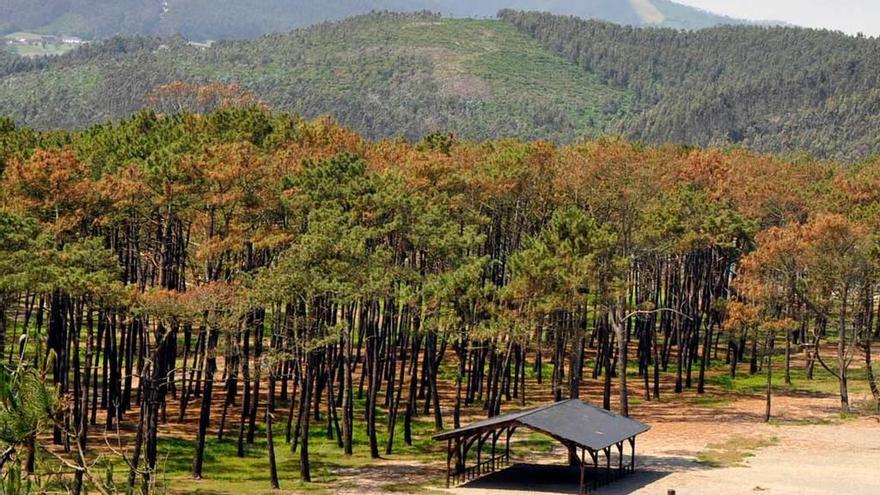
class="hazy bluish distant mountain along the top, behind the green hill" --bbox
[0,0,756,40]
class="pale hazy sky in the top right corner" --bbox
[675,0,880,36]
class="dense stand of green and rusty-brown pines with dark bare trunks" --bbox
[0,104,880,493]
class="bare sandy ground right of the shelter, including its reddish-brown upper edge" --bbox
[449,397,880,495]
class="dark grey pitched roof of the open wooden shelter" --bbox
[434,399,650,450]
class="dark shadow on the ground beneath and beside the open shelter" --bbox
[459,456,707,495]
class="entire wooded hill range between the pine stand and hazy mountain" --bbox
[0,10,880,160]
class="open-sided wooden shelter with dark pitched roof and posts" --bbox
[434,399,649,493]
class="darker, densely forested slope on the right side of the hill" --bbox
[501,11,880,159]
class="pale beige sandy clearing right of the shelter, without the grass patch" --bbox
[450,418,880,495]
